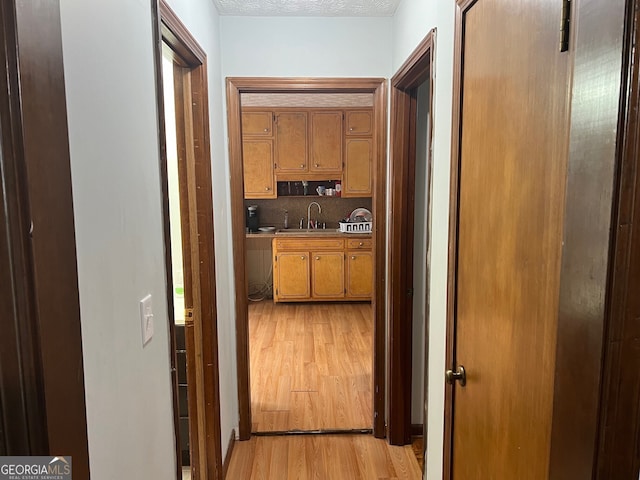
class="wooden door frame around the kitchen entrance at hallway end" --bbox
[227,77,387,440]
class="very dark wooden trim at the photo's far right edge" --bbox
[594,0,640,480]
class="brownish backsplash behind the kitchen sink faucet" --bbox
[244,195,375,228]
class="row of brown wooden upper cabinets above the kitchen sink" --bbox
[242,107,375,198]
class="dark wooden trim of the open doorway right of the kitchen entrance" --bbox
[388,30,435,445]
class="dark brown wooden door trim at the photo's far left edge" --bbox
[0,0,89,472]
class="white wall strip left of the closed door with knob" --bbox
[392,0,455,478]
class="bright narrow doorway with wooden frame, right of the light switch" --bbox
[154,0,224,480]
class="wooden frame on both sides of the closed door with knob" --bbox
[443,0,629,474]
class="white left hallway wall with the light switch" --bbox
[60,0,238,480]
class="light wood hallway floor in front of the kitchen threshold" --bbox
[226,435,422,480]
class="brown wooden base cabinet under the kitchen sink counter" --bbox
[273,237,373,302]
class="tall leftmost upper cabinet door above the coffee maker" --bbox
[242,139,277,198]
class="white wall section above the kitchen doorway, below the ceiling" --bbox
[221,16,391,77]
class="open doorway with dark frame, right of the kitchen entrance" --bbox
[389,30,435,458]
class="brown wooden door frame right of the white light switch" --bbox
[151,0,224,480]
